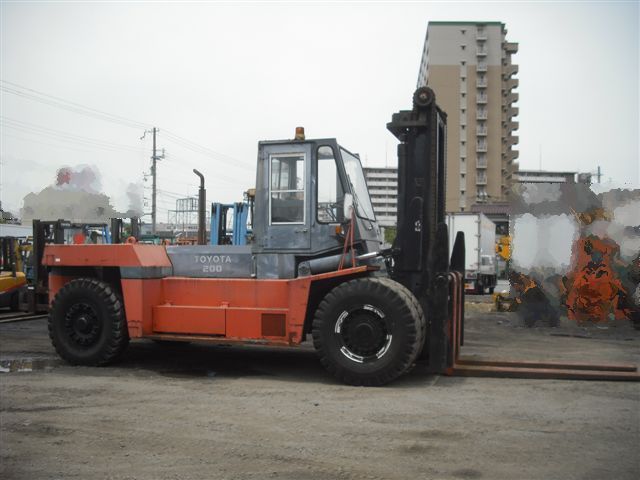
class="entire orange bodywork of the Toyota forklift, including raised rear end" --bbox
[43,244,372,345]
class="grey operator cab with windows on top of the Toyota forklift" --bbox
[253,133,382,278]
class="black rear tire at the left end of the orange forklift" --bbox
[48,278,129,366]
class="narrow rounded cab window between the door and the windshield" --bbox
[316,146,344,223]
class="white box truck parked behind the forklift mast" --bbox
[447,213,498,295]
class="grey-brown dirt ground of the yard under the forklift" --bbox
[0,304,640,480]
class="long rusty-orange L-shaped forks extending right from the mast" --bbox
[443,272,640,382]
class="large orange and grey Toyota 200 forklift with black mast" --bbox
[42,87,629,386]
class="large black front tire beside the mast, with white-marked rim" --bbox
[312,277,427,386]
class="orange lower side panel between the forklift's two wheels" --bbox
[132,267,368,345]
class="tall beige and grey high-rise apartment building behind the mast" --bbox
[418,22,518,212]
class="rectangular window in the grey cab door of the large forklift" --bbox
[269,153,306,224]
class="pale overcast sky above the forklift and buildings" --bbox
[0,2,640,221]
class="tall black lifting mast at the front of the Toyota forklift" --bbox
[387,87,456,373]
